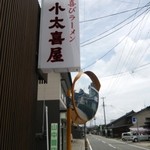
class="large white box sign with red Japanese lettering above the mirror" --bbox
[38,0,80,73]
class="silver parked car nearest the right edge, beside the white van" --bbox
[131,134,150,142]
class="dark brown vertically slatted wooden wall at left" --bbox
[0,0,40,150]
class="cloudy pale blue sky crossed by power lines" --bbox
[38,0,150,125]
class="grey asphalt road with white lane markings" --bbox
[87,135,150,150]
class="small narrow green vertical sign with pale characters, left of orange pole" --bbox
[50,123,58,150]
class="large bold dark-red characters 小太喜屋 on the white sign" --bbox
[47,3,65,62]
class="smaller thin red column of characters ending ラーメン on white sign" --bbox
[68,0,76,42]
